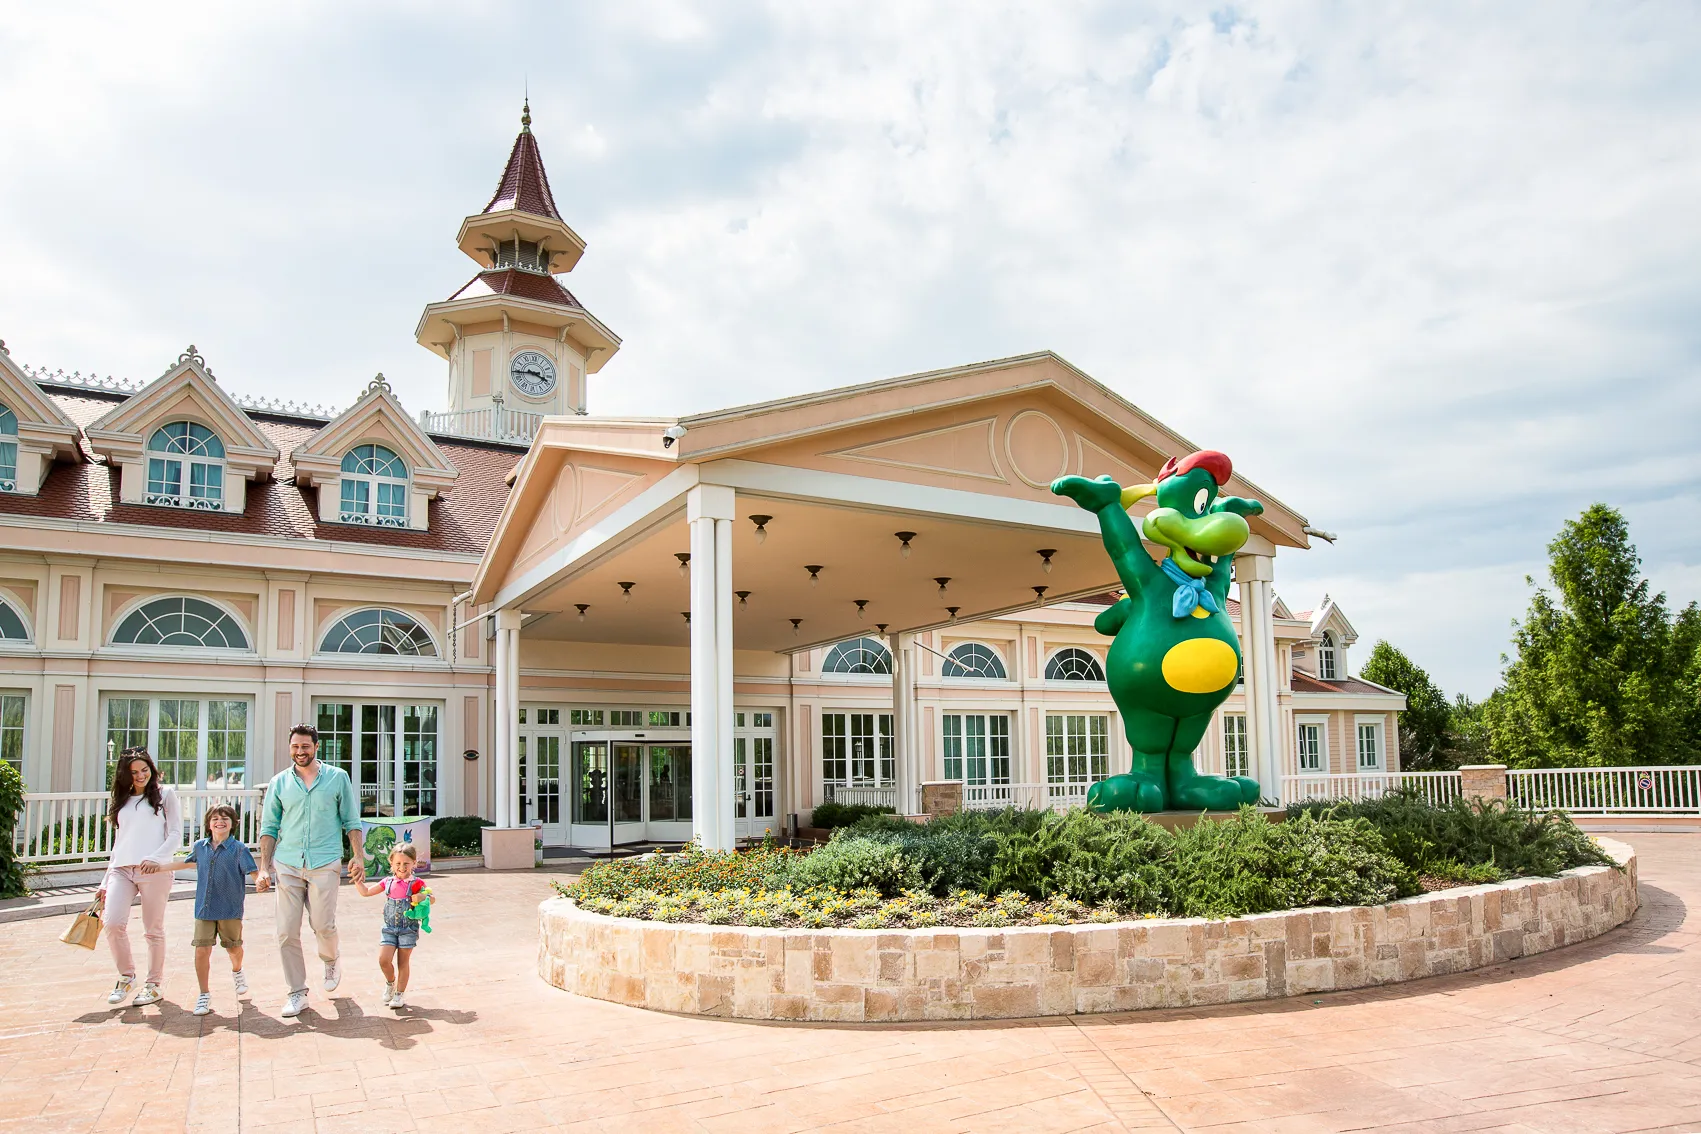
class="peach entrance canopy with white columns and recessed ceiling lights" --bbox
[473,354,1308,848]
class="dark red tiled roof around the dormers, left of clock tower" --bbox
[0,389,526,556]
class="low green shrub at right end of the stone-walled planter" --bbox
[1288,789,1613,881]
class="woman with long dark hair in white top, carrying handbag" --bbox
[97,748,184,1005]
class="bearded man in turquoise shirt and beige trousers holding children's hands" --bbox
[255,724,366,1017]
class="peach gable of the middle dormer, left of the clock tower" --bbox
[85,347,279,479]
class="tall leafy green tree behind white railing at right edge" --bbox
[1482,503,1701,767]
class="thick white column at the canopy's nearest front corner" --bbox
[686,485,735,848]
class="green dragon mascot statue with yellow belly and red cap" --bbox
[1051,449,1264,811]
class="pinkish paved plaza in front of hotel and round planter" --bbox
[0,835,1701,1134]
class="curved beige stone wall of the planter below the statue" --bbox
[538,840,1636,1020]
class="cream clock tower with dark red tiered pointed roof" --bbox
[413,102,621,421]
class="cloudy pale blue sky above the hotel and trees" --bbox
[0,0,1701,695]
